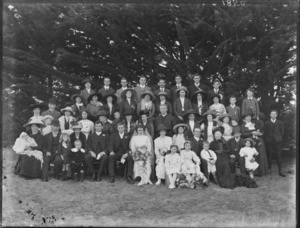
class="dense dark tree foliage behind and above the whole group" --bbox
[2,4,298,143]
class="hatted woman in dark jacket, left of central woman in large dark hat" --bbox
[119,88,137,120]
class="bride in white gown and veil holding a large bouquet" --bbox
[130,125,152,186]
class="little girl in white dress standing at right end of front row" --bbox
[240,138,259,179]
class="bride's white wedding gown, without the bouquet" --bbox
[130,135,151,182]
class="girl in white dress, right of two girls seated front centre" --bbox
[180,140,203,188]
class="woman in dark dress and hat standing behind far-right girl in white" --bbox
[241,112,268,176]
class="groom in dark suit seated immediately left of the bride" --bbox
[108,122,134,184]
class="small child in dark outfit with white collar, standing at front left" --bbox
[70,140,85,182]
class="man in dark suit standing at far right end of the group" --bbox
[265,110,285,177]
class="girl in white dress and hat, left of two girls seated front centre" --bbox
[165,144,181,189]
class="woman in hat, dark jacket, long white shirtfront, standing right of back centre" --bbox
[173,86,193,123]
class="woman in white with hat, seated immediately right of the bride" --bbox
[154,124,172,185]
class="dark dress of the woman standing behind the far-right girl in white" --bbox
[241,120,268,176]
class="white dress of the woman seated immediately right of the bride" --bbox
[154,136,172,179]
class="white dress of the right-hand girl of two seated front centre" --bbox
[180,150,200,174]
